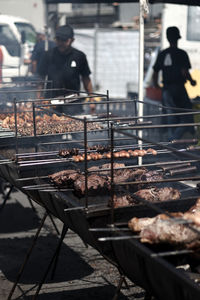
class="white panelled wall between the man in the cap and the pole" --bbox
[73,29,139,98]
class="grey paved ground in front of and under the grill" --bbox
[0,192,144,300]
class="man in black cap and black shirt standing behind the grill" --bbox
[38,25,94,110]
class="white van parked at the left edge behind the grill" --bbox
[0,15,36,78]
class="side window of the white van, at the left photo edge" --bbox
[0,24,20,56]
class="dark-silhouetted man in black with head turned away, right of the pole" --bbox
[153,26,196,140]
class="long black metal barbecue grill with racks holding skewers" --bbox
[0,90,200,299]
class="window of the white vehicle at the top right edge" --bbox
[187,6,200,41]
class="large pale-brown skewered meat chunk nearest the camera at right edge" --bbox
[128,198,200,248]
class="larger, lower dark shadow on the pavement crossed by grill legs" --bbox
[0,235,93,284]
